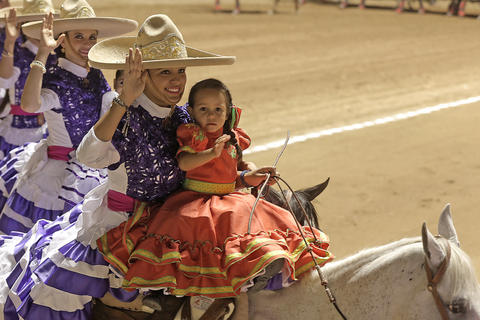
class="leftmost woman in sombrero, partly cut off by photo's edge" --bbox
[0,0,57,160]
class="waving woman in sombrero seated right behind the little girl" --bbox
[0,15,234,319]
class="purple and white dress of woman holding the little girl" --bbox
[0,95,190,320]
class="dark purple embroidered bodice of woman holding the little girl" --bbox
[108,104,190,201]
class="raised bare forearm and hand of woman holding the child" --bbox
[93,48,147,141]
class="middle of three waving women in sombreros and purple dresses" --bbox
[0,0,137,234]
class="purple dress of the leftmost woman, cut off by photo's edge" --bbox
[0,31,57,160]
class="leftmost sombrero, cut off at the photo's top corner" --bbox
[0,0,59,23]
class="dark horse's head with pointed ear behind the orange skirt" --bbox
[265,178,330,228]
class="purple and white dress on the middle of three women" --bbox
[0,58,110,234]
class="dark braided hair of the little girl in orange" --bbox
[188,78,243,161]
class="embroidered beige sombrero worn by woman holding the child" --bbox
[88,14,235,70]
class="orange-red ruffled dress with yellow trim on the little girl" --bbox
[97,124,333,298]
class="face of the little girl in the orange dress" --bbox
[191,89,227,132]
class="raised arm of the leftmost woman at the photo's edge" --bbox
[0,9,20,79]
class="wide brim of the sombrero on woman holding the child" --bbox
[88,37,236,70]
